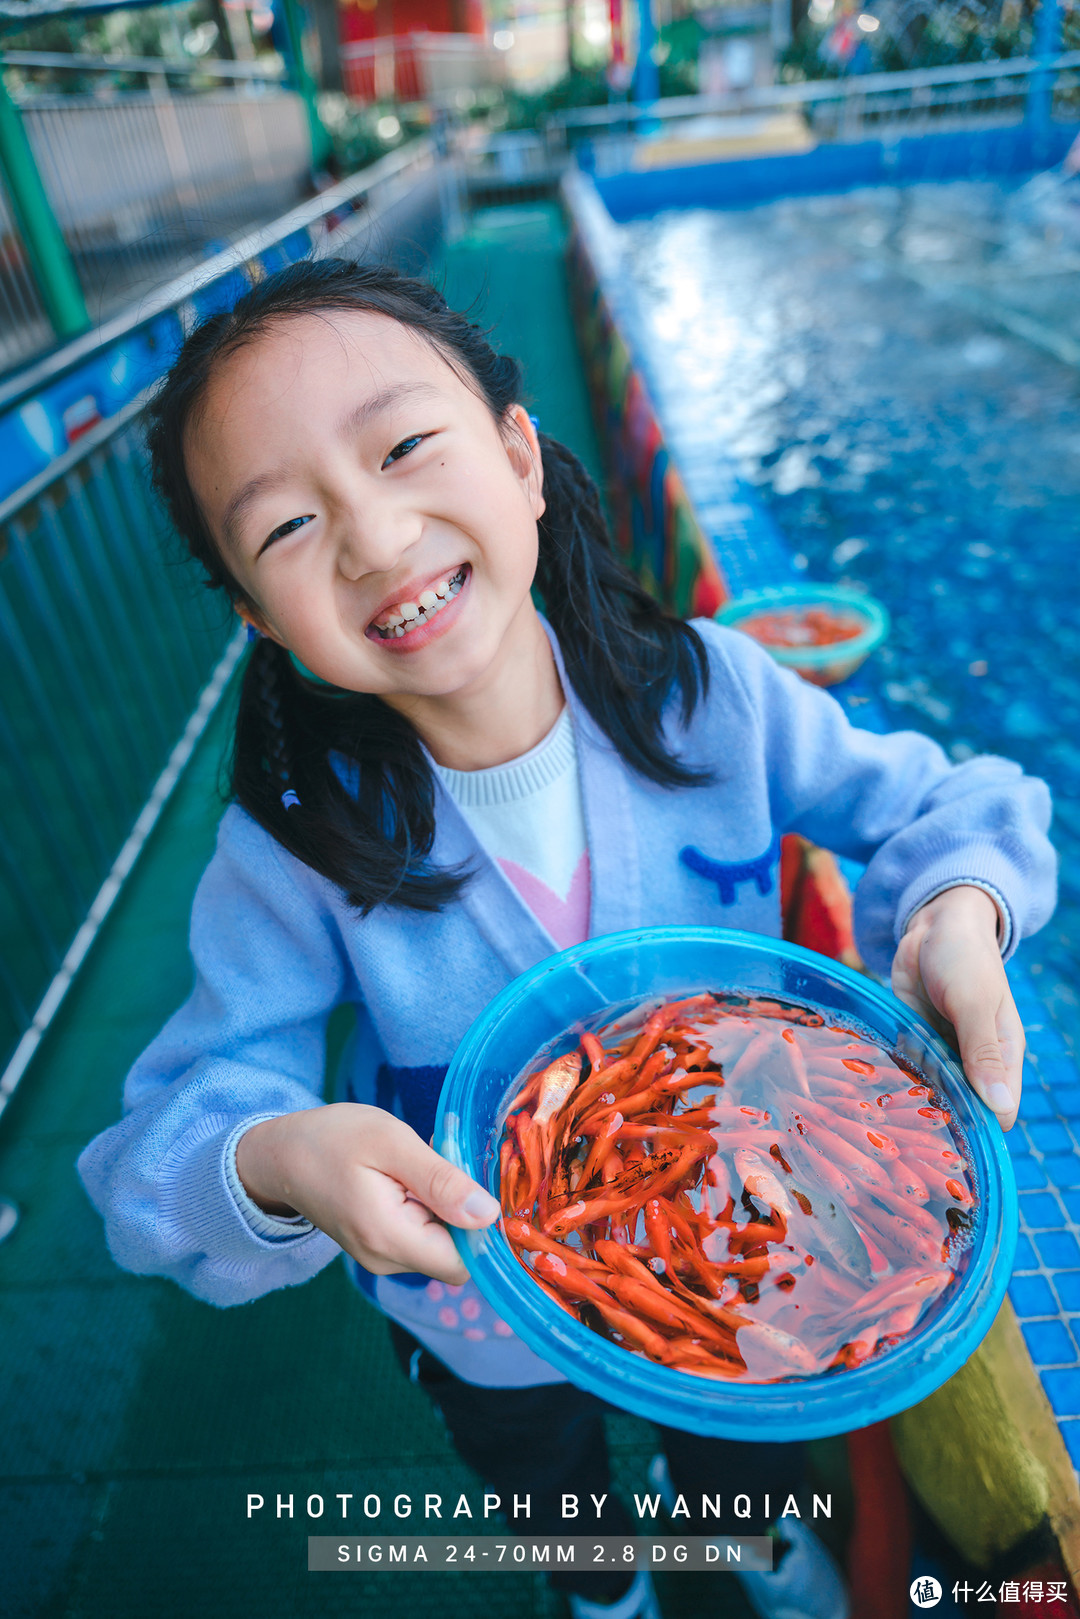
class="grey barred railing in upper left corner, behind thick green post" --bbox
[0,52,311,364]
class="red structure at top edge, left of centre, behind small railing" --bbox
[338,0,487,102]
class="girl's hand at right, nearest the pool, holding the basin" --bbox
[892,884,1023,1130]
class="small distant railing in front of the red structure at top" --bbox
[342,32,505,104]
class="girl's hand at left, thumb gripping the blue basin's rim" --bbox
[236,1103,499,1284]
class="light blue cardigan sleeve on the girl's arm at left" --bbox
[78,808,353,1305]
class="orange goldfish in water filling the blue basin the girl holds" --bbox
[499,994,976,1383]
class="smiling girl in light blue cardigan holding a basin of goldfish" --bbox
[79,261,1054,1619]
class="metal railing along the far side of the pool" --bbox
[544,50,1080,172]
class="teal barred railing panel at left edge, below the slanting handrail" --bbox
[0,402,242,1106]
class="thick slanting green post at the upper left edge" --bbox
[0,66,91,337]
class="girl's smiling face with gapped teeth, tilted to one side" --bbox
[185,311,544,701]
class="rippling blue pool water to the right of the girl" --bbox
[620,181,1080,1010]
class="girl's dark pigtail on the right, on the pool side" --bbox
[536,434,709,787]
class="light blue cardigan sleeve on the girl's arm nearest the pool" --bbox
[706,625,1057,973]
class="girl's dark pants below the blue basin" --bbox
[390,1321,803,1603]
